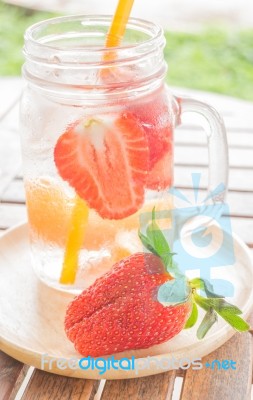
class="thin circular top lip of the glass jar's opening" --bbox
[24,14,164,55]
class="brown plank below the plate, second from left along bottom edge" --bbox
[22,370,99,400]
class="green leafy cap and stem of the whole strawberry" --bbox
[139,208,249,339]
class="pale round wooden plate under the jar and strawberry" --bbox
[0,224,253,379]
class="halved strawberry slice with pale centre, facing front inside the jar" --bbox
[54,113,149,219]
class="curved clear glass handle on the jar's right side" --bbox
[177,97,228,203]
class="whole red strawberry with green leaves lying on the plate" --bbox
[65,210,249,357]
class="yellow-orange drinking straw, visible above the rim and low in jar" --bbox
[60,0,134,285]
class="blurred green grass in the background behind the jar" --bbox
[0,1,253,100]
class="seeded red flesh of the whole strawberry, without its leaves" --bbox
[65,253,191,357]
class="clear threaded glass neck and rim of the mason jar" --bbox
[22,15,167,98]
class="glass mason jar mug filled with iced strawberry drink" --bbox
[21,16,227,292]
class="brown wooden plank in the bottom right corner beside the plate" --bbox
[181,332,253,400]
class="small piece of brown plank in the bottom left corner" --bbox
[0,352,29,400]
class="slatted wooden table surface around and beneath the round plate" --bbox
[0,78,253,400]
